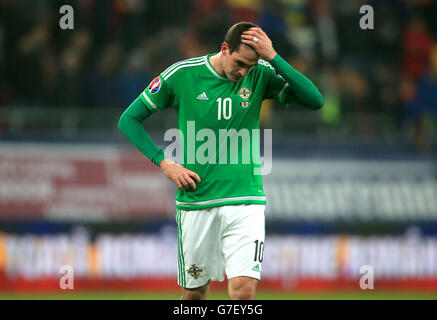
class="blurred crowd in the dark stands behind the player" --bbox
[0,0,437,150]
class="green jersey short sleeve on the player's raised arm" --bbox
[259,60,293,107]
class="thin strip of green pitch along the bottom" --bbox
[0,290,437,300]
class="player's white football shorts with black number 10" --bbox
[176,204,265,288]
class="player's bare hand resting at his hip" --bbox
[160,159,200,193]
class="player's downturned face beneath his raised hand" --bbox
[223,46,259,82]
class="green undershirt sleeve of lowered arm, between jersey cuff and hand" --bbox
[118,98,164,166]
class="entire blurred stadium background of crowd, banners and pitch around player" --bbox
[0,0,437,299]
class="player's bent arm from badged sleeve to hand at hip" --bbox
[118,78,200,193]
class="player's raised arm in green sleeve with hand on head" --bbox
[241,27,323,109]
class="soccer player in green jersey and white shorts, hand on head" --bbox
[119,22,323,300]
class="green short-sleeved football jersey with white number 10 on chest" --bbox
[140,54,292,210]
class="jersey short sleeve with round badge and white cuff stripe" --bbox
[140,75,175,112]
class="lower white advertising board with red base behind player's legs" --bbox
[0,229,437,292]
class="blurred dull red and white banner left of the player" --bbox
[0,144,175,221]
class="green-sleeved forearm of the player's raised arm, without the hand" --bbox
[270,54,323,109]
